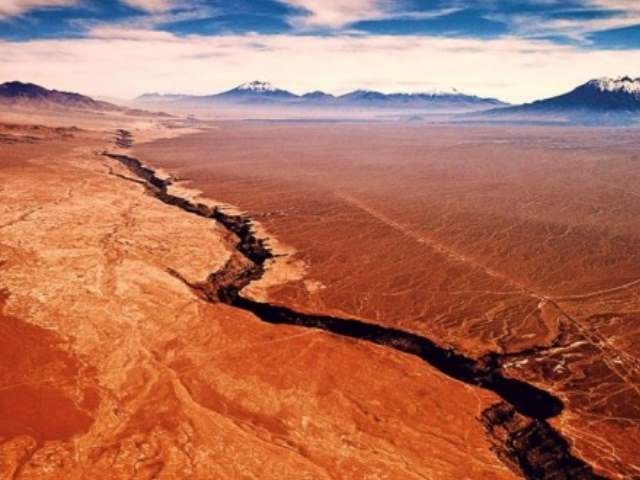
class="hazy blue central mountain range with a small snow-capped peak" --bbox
[135,81,506,110]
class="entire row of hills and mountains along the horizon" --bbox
[0,76,640,123]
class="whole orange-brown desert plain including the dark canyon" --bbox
[0,118,640,479]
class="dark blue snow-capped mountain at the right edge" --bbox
[485,77,640,123]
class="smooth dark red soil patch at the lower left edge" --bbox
[0,286,98,444]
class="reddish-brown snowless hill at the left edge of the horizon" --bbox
[0,81,166,116]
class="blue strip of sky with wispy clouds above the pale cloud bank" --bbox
[0,0,640,45]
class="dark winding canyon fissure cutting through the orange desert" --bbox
[103,147,604,480]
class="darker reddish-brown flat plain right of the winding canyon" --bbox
[136,123,640,478]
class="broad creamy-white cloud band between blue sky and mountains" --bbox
[0,28,640,102]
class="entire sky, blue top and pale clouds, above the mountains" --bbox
[0,0,640,103]
